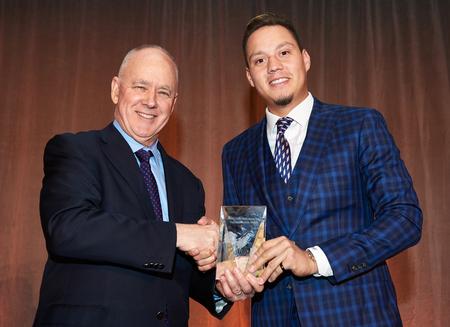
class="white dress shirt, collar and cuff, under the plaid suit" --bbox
[266,92,333,277]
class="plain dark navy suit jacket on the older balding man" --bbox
[35,124,226,327]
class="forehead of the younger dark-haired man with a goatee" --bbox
[247,25,298,57]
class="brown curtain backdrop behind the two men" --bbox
[0,0,450,327]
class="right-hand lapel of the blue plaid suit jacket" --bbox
[289,99,334,238]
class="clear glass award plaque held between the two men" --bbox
[217,206,267,276]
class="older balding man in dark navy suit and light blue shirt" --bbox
[34,46,227,327]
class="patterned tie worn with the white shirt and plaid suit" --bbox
[275,117,293,183]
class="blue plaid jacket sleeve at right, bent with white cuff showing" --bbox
[319,111,422,283]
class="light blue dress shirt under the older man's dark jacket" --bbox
[113,120,169,221]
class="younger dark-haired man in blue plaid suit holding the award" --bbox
[217,14,422,326]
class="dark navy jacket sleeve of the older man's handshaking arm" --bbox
[40,134,176,273]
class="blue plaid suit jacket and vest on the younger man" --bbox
[222,99,422,326]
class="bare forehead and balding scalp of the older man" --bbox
[122,49,176,87]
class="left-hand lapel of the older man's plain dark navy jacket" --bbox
[101,124,154,219]
